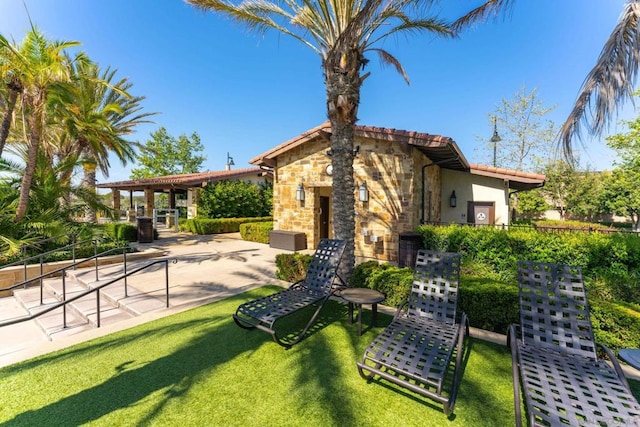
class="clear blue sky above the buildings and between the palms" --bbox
[0,0,634,182]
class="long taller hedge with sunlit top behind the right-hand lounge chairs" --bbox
[418,226,640,303]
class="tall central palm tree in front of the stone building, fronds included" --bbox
[187,0,511,275]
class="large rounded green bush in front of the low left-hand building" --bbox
[198,180,273,218]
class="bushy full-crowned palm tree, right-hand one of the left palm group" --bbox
[56,54,155,222]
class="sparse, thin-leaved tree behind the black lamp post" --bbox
[481,86,556,171]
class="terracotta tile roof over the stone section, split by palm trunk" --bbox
[249,121,468,170]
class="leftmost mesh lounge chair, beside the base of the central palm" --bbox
[233,239,345,348]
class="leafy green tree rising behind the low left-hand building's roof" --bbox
[131,127,206,179]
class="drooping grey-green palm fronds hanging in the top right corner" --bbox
[559,0,640,162]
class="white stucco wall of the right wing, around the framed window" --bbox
[441,169,509,224]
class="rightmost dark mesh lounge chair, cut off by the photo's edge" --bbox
[509,261,640,426]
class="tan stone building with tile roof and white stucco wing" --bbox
[250,122,545,261]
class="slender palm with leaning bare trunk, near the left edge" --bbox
[0,27,79,222]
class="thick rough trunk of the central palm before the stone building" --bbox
[324,43,363,280]
